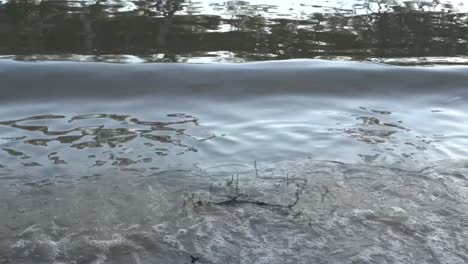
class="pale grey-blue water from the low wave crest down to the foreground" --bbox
[0,60,468,264]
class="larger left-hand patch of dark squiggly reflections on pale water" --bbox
[0,113,216,171]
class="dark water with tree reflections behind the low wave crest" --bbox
[0,0,468,64]
